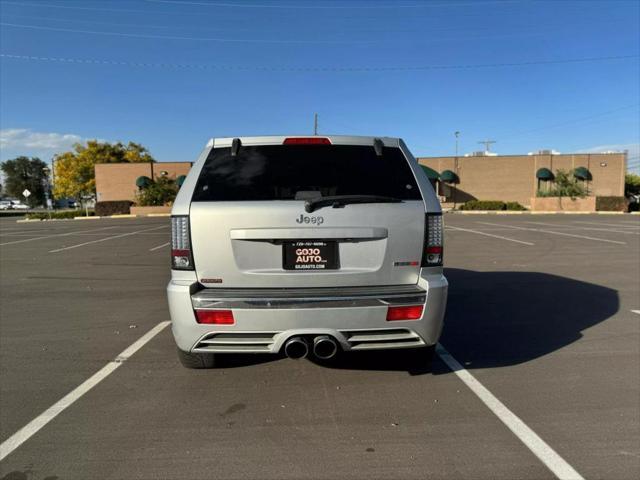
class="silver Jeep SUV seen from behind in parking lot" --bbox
[167,136,448,368]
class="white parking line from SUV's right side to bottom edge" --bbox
[436,344,584,480]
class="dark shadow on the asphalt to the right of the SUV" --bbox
[434,268,620,373]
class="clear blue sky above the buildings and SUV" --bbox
[0,0,640,170]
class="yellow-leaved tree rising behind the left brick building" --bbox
[54,140,155,198]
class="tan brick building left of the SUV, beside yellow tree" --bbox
[95,162,192,202]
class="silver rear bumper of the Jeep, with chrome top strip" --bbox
[167,274,448,353]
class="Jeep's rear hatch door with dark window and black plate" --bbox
[190,137,425,288]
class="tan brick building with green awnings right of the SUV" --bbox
[418,152,627,206]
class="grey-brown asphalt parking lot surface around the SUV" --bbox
[0,215,640,480]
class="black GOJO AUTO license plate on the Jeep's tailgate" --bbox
[282,240,340,272]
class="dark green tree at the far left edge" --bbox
[0,156,49,207]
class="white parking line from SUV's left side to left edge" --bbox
[0,321,171,461]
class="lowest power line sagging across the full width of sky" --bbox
[0,53,640,72]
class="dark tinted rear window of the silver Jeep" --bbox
[192,145,422,202]
